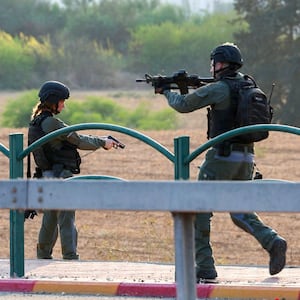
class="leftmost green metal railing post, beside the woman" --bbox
[9,133,24,277]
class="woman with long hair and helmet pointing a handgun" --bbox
[24,81,124,260]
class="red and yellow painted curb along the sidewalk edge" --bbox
[0,279,300,300]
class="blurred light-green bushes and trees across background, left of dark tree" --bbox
[0,0,239,89]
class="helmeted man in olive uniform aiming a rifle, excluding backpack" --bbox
[142,43,287,282]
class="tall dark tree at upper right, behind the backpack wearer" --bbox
[234,0,300,126]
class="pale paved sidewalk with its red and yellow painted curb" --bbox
[0,259,300,300]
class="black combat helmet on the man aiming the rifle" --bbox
[210,43,243,69]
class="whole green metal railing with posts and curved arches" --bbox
[0,123,300,277]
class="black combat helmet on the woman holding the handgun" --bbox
[39,81,70,104]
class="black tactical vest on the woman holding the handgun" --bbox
[28,111,81,174]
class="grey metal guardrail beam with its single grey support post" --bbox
[0,179,300,300]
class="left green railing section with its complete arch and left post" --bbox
[8,123,175,277]
